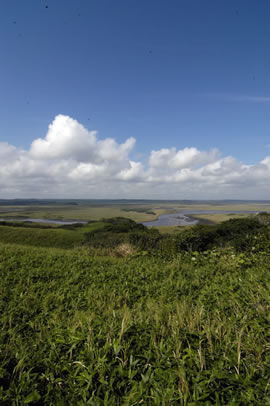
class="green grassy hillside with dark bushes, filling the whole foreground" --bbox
[0,214,270,406]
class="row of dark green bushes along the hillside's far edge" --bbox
[85,217,269,255]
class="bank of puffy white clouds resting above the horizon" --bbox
[0,114,270,199]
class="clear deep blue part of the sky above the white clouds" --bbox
[0,0,270,198]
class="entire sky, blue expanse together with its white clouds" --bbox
[0,0,270,200]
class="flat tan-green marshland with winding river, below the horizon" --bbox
[0,199,270,230]
